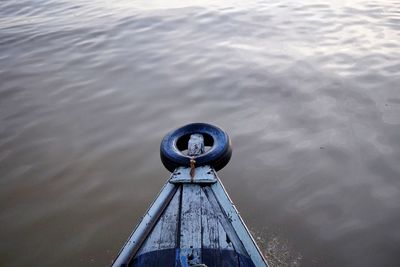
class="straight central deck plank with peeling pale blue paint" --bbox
[180,184,201,265]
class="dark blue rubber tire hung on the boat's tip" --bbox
[160,123,232,172]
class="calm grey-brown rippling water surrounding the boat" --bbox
[0,0,400,266]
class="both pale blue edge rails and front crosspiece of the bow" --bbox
[112,166,268,267]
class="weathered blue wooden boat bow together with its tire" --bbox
[112,124,268,267]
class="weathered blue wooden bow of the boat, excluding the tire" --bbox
[113,166,268,267]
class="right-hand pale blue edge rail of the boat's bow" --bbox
[206,177,268,267]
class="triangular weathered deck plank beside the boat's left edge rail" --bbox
[136,187,181,256]
